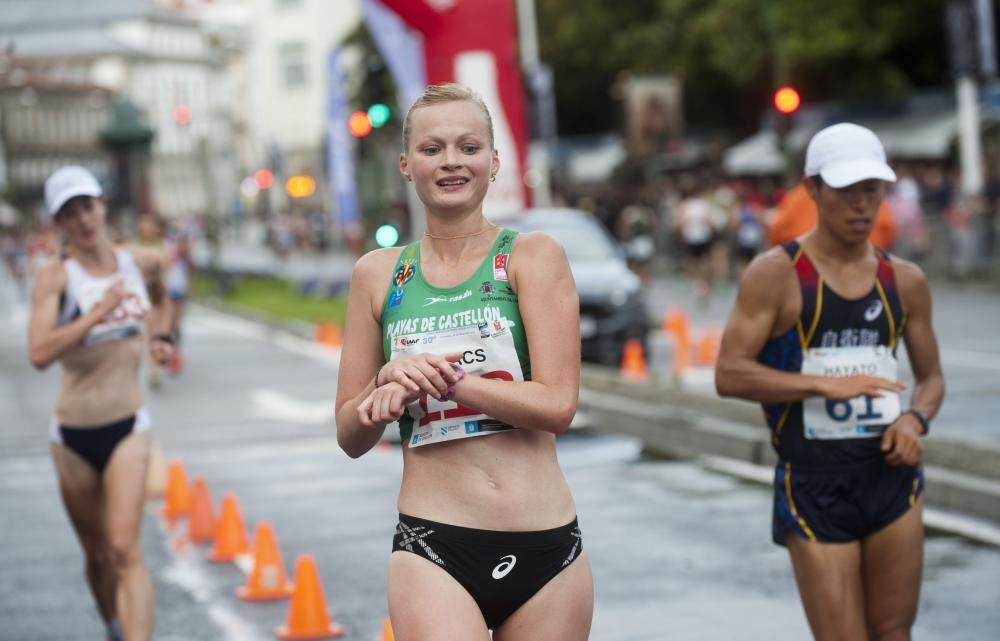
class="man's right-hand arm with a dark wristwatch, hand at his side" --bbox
[882,259,944,465]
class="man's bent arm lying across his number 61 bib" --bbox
[715,247,904,403]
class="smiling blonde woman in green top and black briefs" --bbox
[337,85,594,641]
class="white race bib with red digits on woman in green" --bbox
[392,318,524,447]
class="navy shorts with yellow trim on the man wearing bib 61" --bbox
[771,456,924,545]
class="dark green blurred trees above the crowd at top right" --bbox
[536,0,948,134]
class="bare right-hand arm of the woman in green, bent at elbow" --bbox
[446,232,580,433]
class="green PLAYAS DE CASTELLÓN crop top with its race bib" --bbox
[382,229,531,447]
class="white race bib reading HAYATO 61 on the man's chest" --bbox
[802,345,900,440]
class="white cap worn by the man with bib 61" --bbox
[805,122,896,189]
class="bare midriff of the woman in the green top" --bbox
[399,429,576,532]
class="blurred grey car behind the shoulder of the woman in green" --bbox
[493,209,648,366]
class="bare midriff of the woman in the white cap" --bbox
[56,336,145,427]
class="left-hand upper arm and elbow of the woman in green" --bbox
[336,249,399,458]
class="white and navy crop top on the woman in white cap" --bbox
[59,249,151,345]
